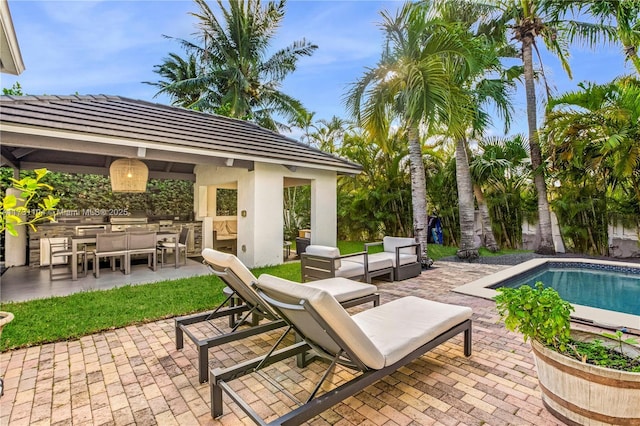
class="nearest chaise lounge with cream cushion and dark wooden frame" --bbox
[209,274,472,425]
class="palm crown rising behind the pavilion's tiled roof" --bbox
[151,0,317,130]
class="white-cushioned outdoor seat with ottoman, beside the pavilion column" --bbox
[300,245,393,283]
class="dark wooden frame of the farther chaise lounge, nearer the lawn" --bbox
[175,250,380,383]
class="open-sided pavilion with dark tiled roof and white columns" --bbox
[0,95,361,267]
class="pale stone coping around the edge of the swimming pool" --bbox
[453,258,640,330]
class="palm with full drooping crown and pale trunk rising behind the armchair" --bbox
[346,2,472,265]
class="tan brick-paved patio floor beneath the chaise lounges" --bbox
[0,262,580,426]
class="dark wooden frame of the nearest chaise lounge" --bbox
[209,282,472,425]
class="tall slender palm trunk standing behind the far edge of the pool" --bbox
[522,34,556,254]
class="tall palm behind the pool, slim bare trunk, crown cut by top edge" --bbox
[494,0,614,254]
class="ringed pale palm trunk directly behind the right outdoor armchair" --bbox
[408,125,433,266]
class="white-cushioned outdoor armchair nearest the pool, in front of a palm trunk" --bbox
[364,237,422,281]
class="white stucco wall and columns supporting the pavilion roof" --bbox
[194,163,337,267]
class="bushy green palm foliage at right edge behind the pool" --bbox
[545,78,640,255]
